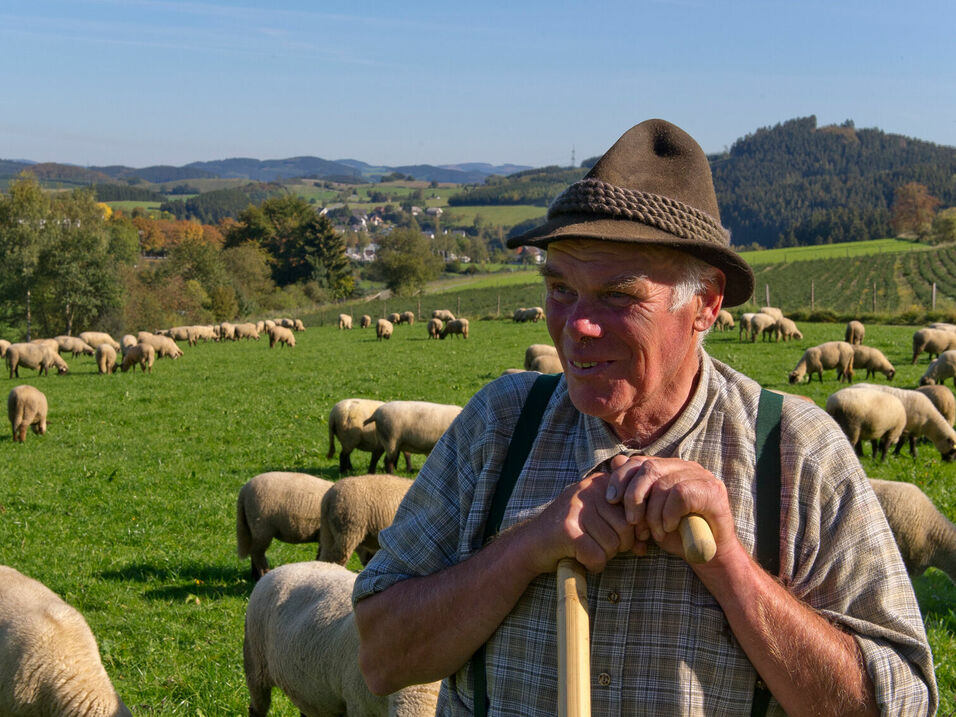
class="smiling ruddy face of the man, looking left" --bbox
[542,239,721,440]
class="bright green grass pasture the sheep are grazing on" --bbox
[0,316,956,717]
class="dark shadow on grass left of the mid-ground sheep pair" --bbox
[100,563,252,602]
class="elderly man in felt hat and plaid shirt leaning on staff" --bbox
[354,120,938,716]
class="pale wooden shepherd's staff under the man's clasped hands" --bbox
[557,514,717,717]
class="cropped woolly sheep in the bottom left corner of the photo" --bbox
[0,565,131,717]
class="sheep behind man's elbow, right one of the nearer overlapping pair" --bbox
[319,475,412,565]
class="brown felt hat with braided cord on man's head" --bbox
[508,119,754,306]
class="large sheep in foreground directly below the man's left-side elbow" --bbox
[242,561,439,717]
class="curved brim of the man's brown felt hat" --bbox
[507,214,754,306]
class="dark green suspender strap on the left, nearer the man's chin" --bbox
[471,373,561,717]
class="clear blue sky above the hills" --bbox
[0,0,956,167]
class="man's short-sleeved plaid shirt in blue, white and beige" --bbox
[354,352,938,717]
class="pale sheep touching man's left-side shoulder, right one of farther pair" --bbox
[365,401,461,473]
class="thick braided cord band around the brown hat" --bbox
[548,177,730,246]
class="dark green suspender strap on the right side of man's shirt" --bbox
[750,389,783,717]
